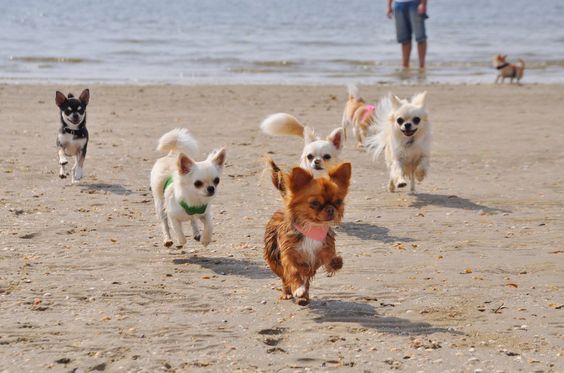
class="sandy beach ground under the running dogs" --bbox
[0,85,564,372]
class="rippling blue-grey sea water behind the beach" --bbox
[0,0,564,84]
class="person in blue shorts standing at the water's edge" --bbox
[387,0,428,69]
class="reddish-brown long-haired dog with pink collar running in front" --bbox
[264,163,351,306]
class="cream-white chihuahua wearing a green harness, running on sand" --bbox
[151,128,229,247]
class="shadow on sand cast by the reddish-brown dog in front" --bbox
[309,299,464,335]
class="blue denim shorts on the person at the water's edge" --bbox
[394,0,427,44]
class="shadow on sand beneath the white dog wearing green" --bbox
[172,256,275,280]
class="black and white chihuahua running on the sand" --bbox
[55,89,90,183]
